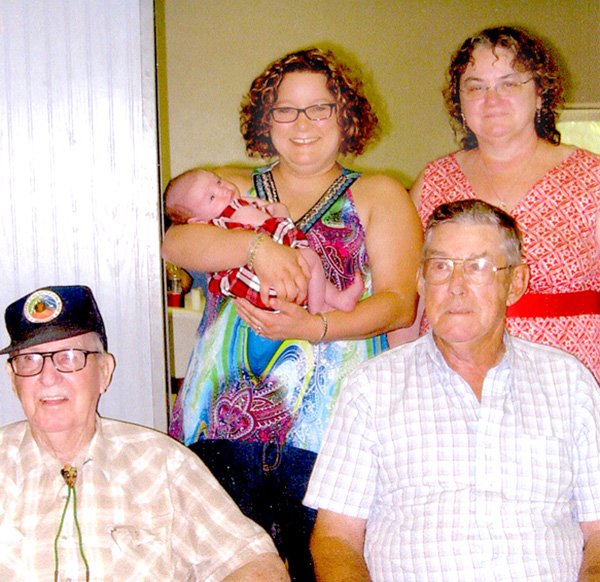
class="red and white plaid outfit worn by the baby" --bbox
[208,198,309,310]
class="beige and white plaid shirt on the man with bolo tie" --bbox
[0,419,275,582]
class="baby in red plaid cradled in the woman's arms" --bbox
[165,169,364,313]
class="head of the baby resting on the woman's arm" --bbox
[165,168,239,224]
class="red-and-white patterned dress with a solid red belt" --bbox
[419,149,600,380]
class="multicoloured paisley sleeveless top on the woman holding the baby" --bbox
[170,166,387,452]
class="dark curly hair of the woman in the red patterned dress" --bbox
[443,26,564,149]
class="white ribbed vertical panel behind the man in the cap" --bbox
[0,0,166,429]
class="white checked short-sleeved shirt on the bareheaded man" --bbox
[304,335,600,582]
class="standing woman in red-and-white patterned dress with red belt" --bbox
[411,26,600,379]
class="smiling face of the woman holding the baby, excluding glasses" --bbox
[270,72,342,174]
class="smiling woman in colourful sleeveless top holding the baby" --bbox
[163,49,422,580]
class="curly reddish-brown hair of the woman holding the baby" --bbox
[240,48,379,157]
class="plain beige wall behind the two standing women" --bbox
[157,0,600,185]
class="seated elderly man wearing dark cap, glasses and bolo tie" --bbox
[0,286,288,581]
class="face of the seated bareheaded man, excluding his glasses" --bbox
[419,222,527,352]
